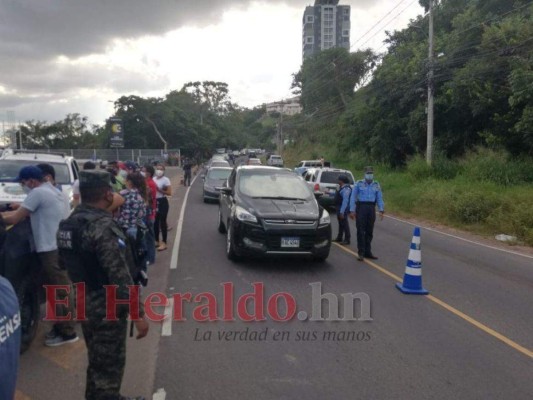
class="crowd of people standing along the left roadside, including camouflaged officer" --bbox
[0,161,176,400]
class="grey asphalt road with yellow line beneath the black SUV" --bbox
[154,175,533,399]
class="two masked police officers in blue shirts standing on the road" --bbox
[334,166,385,261]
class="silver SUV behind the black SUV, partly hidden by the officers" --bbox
[304,168,354,209]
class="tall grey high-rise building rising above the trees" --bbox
[302,0,350,60]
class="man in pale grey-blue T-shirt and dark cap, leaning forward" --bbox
[2,165,79,346]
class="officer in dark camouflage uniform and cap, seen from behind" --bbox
[57,171,148,400]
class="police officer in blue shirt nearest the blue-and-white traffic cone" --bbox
[350,167,385,261]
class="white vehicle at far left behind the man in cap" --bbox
[0,149,79,208]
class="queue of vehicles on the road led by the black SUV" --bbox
[202,155,354,261]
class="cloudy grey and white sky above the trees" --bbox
[0,0,423,123]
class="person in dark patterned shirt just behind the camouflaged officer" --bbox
[116,172,147,238]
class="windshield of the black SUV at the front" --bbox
[239,171,313,200]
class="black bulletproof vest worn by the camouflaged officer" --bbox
[57,213,109,291]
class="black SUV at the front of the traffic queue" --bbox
[218,166,331,261]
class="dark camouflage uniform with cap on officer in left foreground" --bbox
[58,171,144,400]
